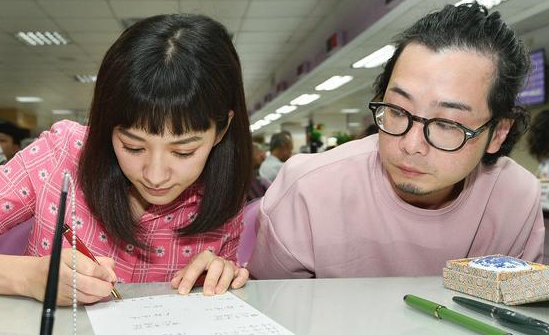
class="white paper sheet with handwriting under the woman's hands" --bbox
[86,292,292,335]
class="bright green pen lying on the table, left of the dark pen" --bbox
[404,294,512,335]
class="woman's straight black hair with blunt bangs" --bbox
[78,14,251,247]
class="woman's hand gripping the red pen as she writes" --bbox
[25,248,117,306]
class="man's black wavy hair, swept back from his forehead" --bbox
[374,2,530,164]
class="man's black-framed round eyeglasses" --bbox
[368,101,496,151]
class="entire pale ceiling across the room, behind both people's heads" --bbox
[0,0,549,135]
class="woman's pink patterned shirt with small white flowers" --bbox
[0,121,242,283]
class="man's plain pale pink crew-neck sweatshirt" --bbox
[248,135,544,279]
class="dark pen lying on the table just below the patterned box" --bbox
[452,297,549,335]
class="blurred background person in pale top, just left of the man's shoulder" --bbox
[259,131,294,182]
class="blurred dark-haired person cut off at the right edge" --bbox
[527,110,549,179]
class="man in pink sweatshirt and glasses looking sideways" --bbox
[248,3,544,279]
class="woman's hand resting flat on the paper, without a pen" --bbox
[172,250,249,295]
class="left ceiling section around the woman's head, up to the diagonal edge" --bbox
[0,0,339,128]
